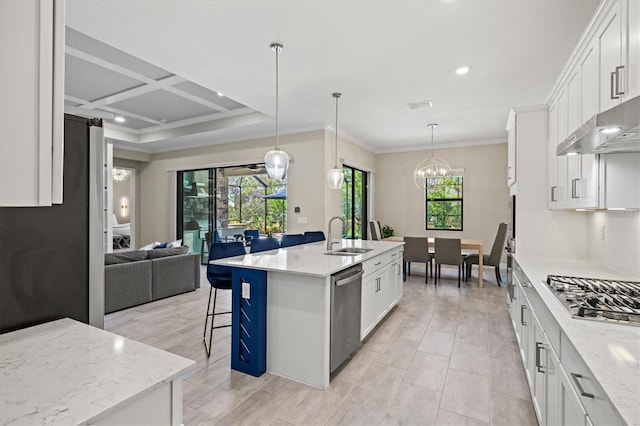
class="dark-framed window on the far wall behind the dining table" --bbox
[426,175,462,231]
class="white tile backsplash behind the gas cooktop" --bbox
[587,210,640,281]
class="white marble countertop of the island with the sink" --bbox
[211,240,404,277]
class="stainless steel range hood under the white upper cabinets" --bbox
[556,96,640,155]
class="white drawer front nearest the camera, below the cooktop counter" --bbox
[560,333,625,425]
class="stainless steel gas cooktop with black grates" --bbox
[547,275,640,326]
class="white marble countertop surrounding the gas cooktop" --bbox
[514,254,640,425]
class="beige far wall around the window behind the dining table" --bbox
[375,140,509,253]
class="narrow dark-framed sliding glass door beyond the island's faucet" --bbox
[342,166,368,240]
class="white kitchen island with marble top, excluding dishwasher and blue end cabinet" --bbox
[212,240,404,389]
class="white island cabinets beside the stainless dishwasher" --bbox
[360,250,402,340]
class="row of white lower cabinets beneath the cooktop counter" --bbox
[509,265,624,426]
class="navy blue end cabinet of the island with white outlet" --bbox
[231,267,267,377]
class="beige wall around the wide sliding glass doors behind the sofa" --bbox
[138,130,327,245]
